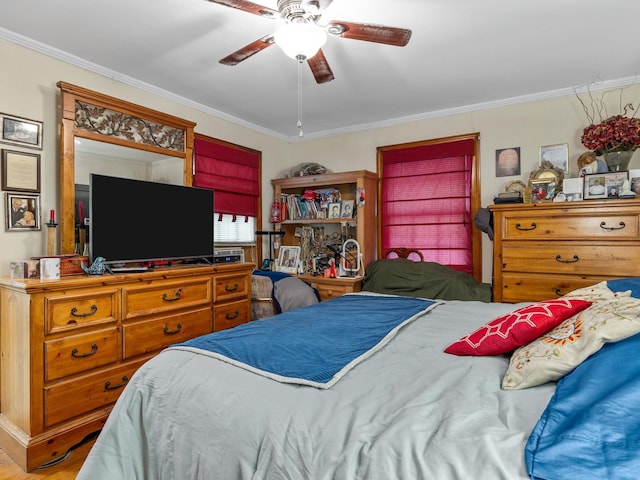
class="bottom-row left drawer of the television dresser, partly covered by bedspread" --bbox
[44,358,147,427]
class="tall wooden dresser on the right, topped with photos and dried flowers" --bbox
[489,199,640,303]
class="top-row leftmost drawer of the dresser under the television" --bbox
[44,290,118,333]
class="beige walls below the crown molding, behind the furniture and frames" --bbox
[0,41,640,281]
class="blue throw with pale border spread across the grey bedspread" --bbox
[172,294,438,388]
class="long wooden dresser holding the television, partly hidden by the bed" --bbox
[0,264,254,470]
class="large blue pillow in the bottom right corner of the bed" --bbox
[525,334,640,480]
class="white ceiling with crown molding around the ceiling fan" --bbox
[0,0,640,141]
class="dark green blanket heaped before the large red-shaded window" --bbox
[362,258,491,302]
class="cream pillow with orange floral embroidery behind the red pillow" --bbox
[502,297,640,390]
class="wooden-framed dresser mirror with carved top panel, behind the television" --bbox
[58,82,195,254]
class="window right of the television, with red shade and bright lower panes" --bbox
[193,134,261,245]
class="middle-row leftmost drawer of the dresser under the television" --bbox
[44,327,118,381]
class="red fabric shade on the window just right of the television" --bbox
[193,138,260,218]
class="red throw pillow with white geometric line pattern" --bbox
[444,298,591,355]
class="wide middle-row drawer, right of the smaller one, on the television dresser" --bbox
[122,307,213,359]
